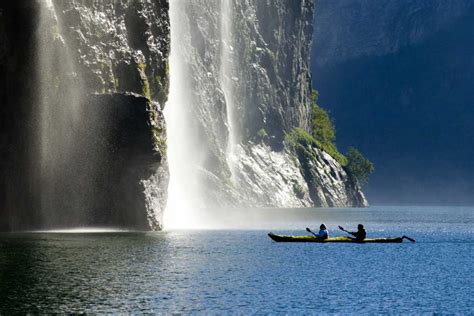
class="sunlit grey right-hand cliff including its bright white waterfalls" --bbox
[165,0,367,222]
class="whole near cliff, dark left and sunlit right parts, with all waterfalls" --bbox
[0,0,366,230]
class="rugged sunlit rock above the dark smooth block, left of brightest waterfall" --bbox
[53,0,169,104]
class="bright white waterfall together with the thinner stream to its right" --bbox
[164,0,238,228]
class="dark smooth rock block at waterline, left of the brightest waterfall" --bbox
[84,94,168,230]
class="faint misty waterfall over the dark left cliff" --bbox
[36,0,95,228]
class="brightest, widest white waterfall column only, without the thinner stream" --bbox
[164,1,202,228]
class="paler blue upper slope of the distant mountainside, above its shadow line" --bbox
[313,0,474,66]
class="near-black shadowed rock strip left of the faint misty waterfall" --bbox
[0,0,37,230]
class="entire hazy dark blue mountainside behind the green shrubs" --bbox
[312,0,474,205]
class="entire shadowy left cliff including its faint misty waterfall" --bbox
[0,0,169,230]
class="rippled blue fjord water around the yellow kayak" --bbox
[0,207,474,314]
